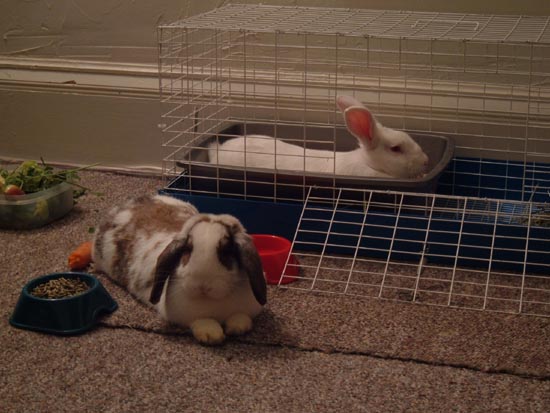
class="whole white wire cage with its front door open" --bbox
[159,4,550,315]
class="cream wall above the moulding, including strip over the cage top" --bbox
[0,0,550,63]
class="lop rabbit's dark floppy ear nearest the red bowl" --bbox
[235,232,267,305]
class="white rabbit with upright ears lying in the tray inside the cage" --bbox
[208,96,428,178]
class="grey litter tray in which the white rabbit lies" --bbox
[175,123,454,200]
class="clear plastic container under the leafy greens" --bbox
[0,182,74,229]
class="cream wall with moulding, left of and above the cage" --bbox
[0,0,550,170]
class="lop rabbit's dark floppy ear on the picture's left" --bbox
[149,237,192,304]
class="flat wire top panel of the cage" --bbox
[161,4,550,44]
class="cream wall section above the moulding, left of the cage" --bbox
[0,0,223,62]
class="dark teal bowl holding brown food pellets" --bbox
[10,272,118,335]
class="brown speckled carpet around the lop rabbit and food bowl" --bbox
[0,172,550,412]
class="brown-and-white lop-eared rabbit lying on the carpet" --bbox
[92,195,266,344]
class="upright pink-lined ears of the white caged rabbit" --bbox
[336,96,378,149]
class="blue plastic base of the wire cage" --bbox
[161,159,550,275]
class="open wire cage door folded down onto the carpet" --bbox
[281,188,550,316]
